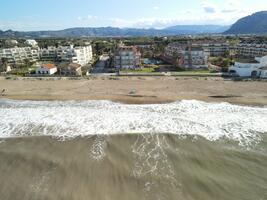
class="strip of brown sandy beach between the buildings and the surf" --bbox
[0,76,267,106]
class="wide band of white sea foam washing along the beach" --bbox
[0,100,267,144]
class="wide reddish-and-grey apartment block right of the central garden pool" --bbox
[164,42,209,69]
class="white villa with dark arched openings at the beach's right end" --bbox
[229,56,267,78]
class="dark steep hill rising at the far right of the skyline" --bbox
[225,11,267,34]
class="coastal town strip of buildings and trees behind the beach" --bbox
[0,36,267,79]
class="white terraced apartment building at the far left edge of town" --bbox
[0,47,39,64]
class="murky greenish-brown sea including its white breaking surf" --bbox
[0,99,267,200]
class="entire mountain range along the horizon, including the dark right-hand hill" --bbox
[0,11,267,38]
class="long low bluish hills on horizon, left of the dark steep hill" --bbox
[0,25,229,38]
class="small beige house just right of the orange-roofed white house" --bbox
[59,63,82,76]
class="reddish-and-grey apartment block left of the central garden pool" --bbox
[114,45,141,69]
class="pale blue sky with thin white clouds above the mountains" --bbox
[0,0,267,31]
